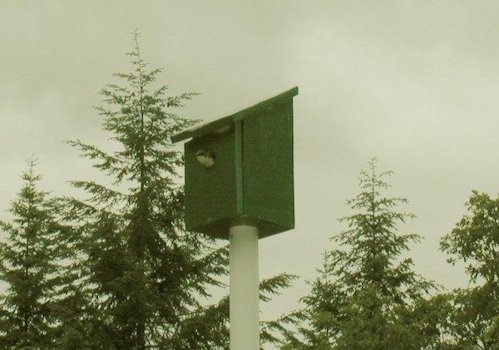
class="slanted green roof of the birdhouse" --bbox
[171,86,298,143]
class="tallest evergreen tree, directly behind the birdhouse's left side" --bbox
[66,33,291,350]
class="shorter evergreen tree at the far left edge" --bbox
[0,159,62,348]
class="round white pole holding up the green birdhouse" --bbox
[229,224,260,350]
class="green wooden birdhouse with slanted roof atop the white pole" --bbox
[172,87,298,239]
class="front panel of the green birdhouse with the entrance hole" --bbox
[185,132,236,234]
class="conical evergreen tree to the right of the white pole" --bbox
[284,159,438,350]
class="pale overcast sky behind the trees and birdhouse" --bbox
[0,0,499,340]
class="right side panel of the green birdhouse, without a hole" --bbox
[243,98,294,236]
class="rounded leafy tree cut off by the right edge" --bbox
[441,191,499,350]
